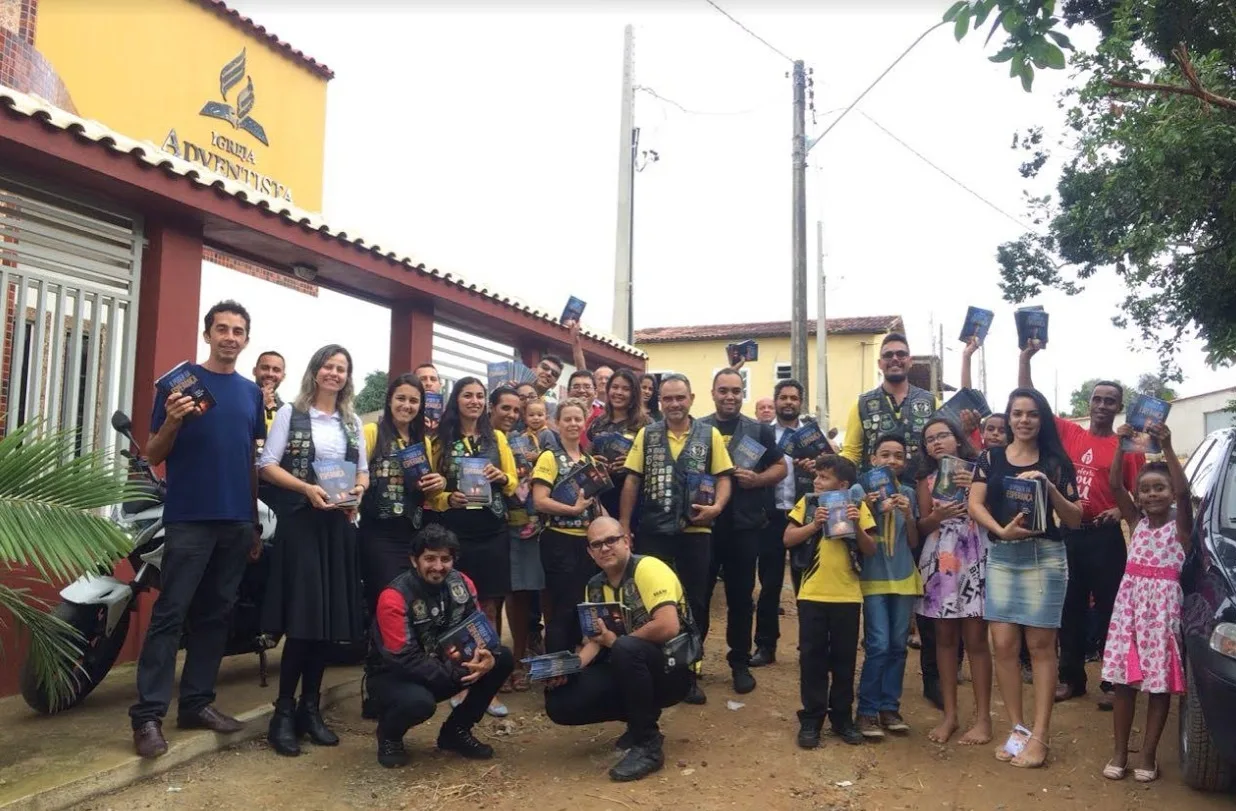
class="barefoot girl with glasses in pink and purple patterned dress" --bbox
[918,419,991,745]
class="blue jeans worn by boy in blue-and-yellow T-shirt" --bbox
[858,595,915,716]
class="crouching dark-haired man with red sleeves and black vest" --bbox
[366,524,514,768]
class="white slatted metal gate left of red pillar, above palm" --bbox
[0,174,142,450]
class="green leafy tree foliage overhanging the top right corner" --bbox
[946,0,1236,380]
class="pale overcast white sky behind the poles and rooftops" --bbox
[201,0,1236,404]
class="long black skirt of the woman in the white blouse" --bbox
[262,507,365,643]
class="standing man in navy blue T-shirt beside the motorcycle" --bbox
[129,300,266,758]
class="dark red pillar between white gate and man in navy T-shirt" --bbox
[131,223,201,445]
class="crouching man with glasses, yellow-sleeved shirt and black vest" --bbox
[545,517,702,783]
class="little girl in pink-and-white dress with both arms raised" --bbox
[1103,425,1193,783]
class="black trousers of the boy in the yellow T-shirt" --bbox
[798,600,861,729]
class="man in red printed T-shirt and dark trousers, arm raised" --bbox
[1017,340,1146,710]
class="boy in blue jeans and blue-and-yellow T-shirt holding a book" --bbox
[858,434,922,738]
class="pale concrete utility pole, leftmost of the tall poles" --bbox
[613,25,639,344]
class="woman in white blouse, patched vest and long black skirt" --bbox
[258,344,370,755]
